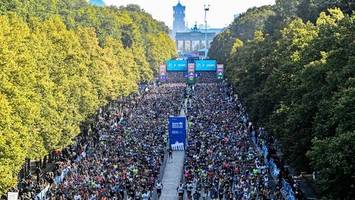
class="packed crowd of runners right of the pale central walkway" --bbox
[180,78,280,200]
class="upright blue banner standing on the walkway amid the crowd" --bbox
[169,116,186,151]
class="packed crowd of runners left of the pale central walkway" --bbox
[18,83,185,200]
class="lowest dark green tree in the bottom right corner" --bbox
[308,131,355,199]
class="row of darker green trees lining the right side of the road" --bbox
[210,0,355,199]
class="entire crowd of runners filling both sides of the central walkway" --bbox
[12,72,300,200]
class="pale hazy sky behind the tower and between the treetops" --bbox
[104,0,275,28]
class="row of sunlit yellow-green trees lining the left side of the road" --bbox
[0,0,176,196]
